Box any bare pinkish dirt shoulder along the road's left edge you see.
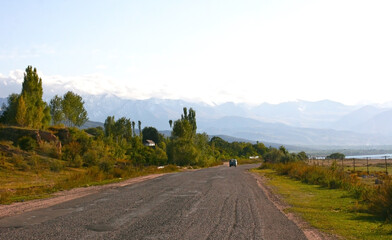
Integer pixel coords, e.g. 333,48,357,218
0,173,164,218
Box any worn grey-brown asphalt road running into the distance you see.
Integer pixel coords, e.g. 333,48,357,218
0,165,306,240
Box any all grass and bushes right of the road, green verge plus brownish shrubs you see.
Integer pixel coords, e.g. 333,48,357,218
255,146,392,239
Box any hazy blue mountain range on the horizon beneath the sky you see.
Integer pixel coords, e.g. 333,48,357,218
0,94,392,146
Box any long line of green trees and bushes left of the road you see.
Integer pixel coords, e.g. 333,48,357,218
0,66,306,173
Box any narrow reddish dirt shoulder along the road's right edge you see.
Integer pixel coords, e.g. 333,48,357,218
251,173,339,240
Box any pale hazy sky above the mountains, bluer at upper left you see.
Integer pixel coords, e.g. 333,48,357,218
0,0,392,104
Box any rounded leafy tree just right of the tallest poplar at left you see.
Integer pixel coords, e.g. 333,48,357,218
62,91,88,127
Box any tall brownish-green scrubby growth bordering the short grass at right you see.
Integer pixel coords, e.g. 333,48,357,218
260,162,392,220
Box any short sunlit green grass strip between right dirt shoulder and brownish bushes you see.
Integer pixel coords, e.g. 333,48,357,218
253,169,392,239
